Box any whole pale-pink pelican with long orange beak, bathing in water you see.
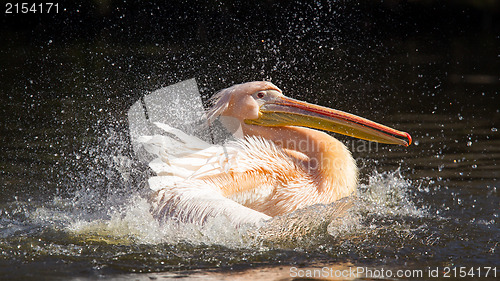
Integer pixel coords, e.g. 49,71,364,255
139,81,411,226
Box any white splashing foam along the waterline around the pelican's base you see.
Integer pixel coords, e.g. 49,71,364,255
27,166,424,248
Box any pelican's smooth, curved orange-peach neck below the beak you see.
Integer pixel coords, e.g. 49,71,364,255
242,124,357,200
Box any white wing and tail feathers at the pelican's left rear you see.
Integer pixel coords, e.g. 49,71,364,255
138,123,271,226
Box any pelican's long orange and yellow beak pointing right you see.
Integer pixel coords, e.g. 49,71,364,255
245,95,411,146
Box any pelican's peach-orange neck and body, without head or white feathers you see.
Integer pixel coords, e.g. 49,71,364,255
213,125,357,217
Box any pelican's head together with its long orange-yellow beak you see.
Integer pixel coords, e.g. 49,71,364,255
208,81,411,146
